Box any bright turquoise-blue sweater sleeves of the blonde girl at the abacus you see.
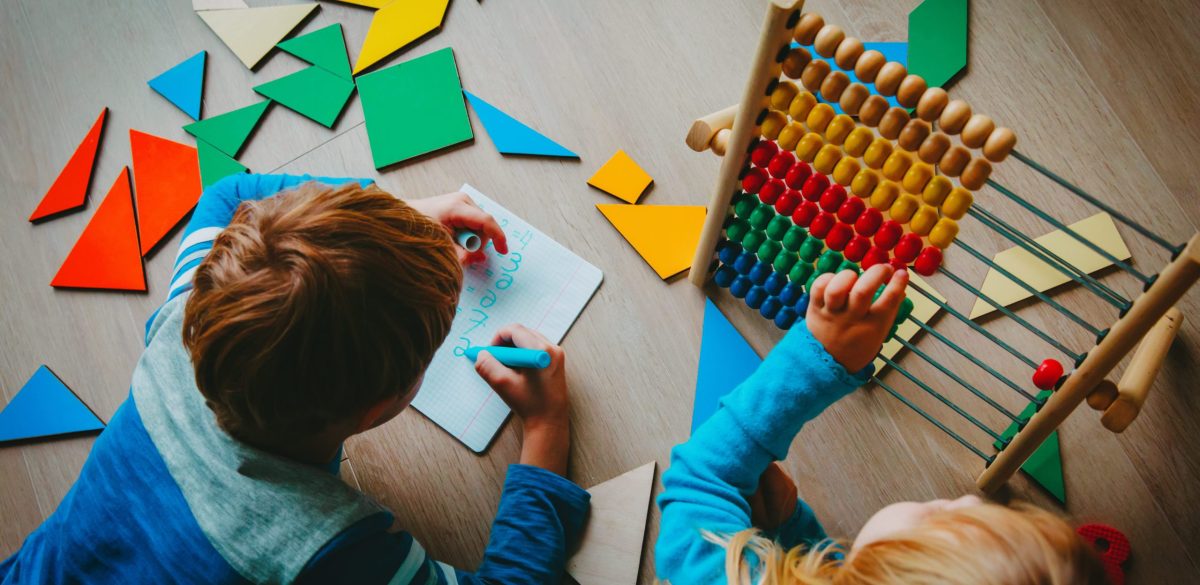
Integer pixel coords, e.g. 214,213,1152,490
654,321,874,585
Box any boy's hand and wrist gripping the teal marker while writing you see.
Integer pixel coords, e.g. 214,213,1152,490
475,325,571,475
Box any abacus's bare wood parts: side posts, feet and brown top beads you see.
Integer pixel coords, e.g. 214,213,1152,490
686,0,1200,493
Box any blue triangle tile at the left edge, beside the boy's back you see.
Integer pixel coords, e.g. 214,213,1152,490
0,366,104,442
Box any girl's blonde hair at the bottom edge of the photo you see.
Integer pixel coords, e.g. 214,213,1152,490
722,503,1109,585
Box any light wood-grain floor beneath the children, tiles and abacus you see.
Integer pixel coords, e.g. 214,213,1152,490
0,0,1200,583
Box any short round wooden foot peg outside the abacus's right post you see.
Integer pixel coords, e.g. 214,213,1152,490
1100,307,1183,433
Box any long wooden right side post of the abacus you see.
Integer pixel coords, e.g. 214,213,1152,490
976,234,1200,493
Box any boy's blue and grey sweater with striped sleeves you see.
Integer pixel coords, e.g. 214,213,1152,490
0,175,588,585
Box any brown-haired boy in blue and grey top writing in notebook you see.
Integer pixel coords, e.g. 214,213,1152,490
0,175,588,584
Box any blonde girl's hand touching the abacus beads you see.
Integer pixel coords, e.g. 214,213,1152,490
805,264,908,373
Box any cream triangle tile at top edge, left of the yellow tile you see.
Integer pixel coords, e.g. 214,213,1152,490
197,2,317,68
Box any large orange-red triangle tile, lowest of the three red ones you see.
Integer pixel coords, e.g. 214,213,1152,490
50,167,146,291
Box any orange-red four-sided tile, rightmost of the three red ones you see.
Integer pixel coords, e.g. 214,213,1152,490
130,129,200,255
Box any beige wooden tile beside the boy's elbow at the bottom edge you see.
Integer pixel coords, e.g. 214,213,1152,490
566,462,654,585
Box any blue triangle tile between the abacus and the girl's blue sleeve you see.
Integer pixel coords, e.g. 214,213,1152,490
691,300,762,433
